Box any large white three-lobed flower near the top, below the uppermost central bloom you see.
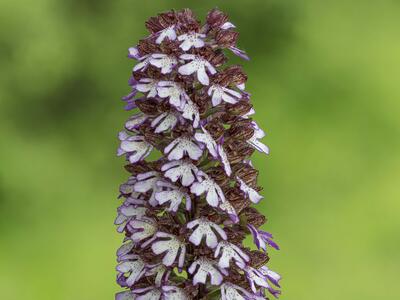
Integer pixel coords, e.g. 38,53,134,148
178,54,217,85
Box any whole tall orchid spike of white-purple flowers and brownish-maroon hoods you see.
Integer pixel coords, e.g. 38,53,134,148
115,9,280,300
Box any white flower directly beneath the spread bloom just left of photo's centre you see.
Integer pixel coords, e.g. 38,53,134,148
161,160,198,186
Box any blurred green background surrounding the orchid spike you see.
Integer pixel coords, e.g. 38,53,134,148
0,0,400,300
